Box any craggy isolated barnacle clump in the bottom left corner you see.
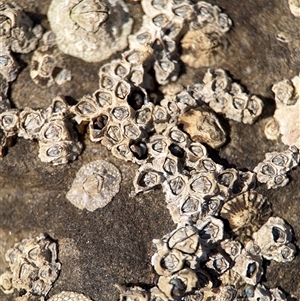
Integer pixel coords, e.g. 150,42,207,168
0,234,61,300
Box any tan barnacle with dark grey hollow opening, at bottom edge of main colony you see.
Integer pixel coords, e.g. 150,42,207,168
157,268,198,300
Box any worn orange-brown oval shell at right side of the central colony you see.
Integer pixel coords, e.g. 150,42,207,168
179,108,226,148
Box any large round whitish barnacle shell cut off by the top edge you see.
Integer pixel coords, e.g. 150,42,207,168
48,0,133,62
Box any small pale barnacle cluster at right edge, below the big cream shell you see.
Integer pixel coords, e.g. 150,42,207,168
254,146,300,189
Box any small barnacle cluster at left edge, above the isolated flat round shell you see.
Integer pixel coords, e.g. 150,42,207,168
0,96,82,165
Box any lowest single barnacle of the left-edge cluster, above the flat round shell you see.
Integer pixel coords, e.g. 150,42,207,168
39,140,82,165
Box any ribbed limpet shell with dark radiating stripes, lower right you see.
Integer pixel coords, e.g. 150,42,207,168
220,190,272,238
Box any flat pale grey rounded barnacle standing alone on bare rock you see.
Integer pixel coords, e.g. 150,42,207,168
66,160,121,211
